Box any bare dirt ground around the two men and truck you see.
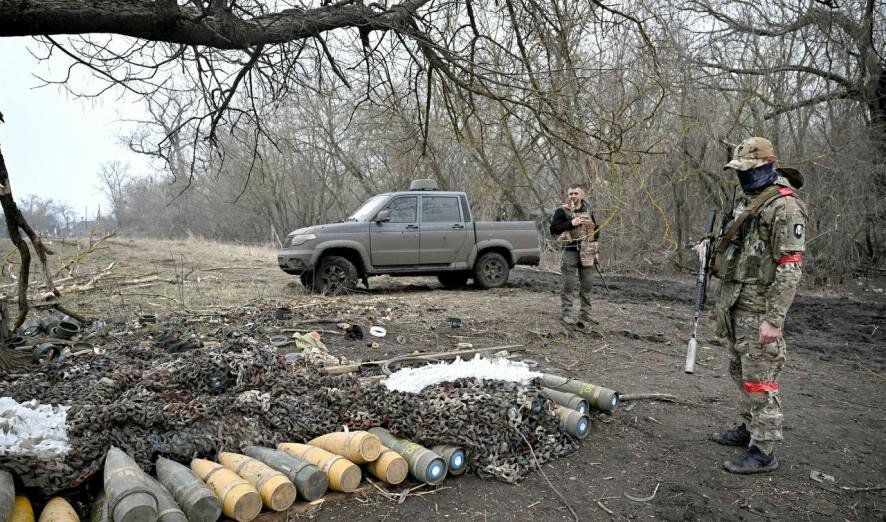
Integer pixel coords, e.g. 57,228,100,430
6,240,886,520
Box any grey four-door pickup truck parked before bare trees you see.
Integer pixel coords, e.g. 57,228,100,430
277,180,540,294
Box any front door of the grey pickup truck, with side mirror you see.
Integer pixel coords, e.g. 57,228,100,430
369,196,419,266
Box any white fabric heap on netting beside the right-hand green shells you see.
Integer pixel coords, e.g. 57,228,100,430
382,354,541,393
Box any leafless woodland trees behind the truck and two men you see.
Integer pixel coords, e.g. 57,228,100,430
6,0,886,277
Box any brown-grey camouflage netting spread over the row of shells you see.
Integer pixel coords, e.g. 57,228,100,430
0,338,578,495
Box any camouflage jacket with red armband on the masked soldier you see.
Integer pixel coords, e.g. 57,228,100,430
717,177,807,336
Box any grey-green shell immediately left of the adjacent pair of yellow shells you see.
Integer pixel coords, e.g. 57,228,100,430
156,457,221,522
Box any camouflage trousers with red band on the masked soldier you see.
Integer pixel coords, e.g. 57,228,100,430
729,310,786,453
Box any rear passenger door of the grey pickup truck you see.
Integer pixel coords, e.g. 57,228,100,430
420,196,468,265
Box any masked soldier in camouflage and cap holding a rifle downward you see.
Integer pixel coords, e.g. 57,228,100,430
712,138,806,474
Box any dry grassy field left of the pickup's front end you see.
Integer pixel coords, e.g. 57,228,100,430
0,238,304,315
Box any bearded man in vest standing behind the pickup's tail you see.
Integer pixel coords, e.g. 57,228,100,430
550,184,600,330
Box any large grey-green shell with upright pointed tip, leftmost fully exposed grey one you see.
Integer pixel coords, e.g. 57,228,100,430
104,447,157,522
